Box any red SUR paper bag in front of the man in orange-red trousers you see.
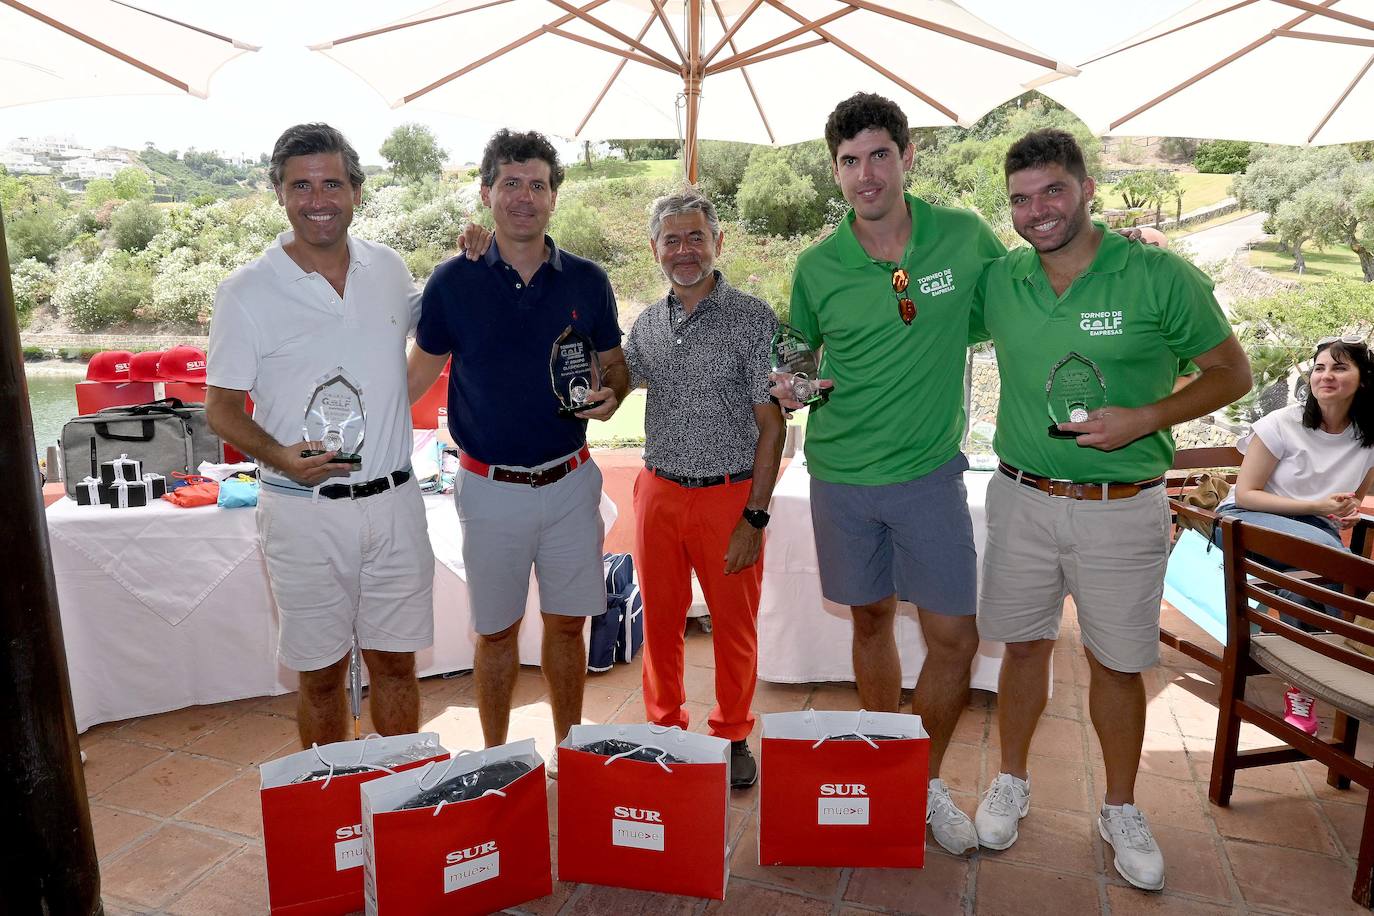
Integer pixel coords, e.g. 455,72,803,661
558,725,730,900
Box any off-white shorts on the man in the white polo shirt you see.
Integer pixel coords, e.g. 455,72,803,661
257,477,434,672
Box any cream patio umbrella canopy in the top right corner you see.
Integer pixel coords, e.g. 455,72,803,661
1043,0,1374,146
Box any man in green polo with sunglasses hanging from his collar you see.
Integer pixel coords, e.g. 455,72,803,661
782,93,1004,854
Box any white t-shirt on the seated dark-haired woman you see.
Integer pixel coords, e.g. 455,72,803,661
1224,404,1374,504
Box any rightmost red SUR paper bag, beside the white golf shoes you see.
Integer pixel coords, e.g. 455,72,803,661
758,710,930,868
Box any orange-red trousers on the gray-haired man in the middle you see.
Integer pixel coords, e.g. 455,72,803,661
635,470,764,742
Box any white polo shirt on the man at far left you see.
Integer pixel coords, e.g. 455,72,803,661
206,232,420,488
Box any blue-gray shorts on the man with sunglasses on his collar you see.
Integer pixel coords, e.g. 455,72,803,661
811,455,978,617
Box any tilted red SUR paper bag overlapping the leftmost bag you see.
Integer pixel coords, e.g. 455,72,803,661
363,740,554,916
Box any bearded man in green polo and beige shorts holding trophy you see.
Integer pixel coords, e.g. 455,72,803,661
970,130,1250,890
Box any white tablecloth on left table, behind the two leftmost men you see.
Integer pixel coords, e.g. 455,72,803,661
48,494,616,732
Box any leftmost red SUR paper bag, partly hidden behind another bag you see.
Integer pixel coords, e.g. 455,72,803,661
260,732,448,916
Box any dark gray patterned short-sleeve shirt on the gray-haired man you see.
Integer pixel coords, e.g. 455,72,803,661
625,271,778,477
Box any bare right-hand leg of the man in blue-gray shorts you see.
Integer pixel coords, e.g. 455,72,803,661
899,610,978,779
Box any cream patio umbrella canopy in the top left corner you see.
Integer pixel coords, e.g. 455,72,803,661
0,0,257,107
